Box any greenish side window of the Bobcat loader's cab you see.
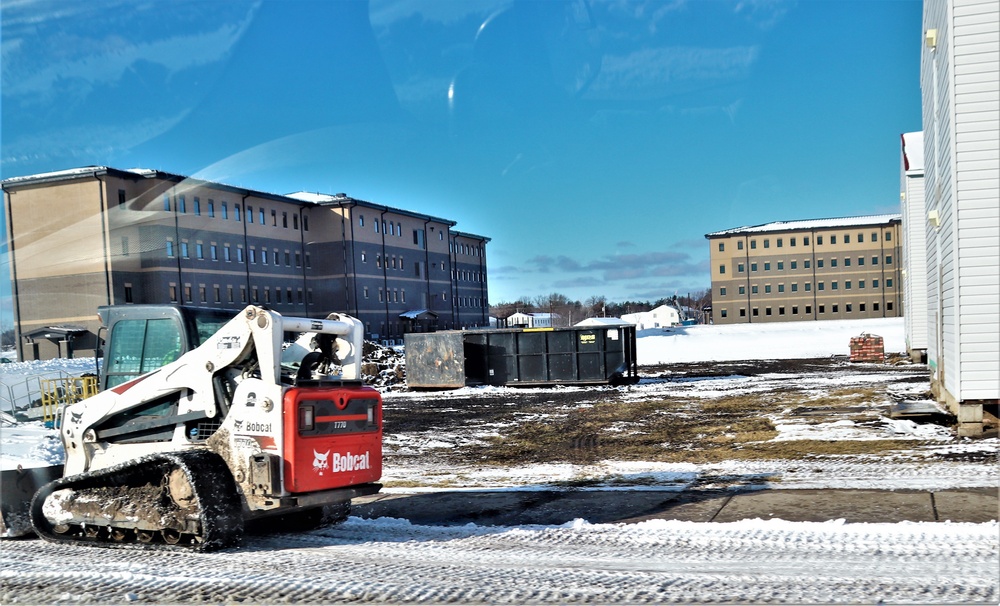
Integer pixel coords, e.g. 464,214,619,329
104,318,183,389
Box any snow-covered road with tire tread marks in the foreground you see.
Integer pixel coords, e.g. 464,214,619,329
0,518,1000,603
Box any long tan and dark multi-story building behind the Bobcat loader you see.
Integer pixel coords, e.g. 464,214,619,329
3,166,489,359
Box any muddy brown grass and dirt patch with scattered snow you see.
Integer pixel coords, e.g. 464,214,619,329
384,358,996,476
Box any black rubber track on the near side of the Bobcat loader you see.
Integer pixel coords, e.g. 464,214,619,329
31,450,243,551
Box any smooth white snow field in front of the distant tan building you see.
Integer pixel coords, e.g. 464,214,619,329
636,318,906,366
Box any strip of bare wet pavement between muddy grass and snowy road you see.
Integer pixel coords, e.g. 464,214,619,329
352,487,1000,526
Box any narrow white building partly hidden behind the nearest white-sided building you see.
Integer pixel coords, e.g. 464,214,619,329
899,132,927,363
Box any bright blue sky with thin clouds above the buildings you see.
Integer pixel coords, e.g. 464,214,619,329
0,0,922,324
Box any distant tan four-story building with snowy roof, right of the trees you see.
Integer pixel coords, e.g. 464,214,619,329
705,215,903,324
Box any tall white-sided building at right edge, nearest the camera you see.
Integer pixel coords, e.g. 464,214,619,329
920,0,1000,436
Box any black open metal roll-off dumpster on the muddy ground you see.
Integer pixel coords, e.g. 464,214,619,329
405,326,639,389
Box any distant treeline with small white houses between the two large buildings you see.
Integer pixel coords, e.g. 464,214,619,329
490,289,712,326
